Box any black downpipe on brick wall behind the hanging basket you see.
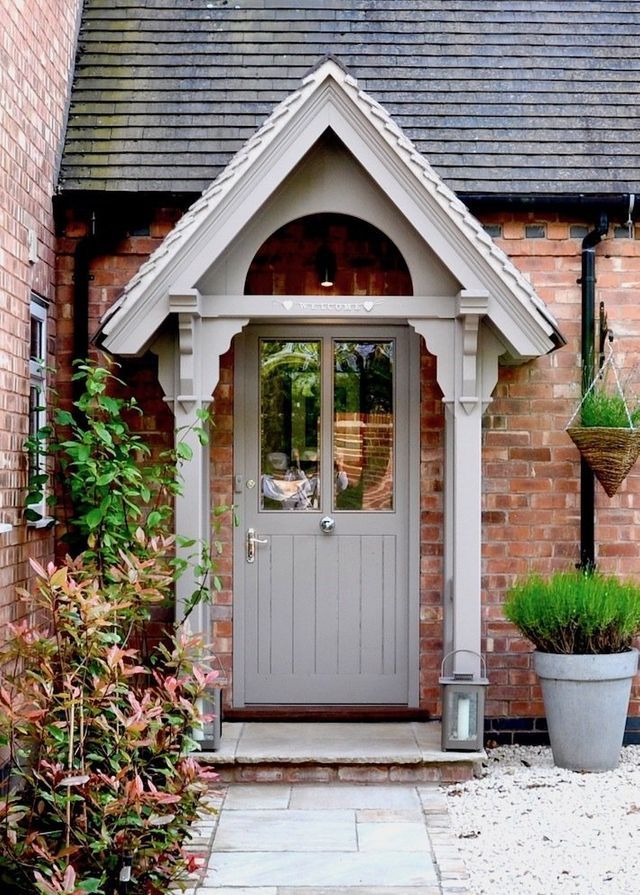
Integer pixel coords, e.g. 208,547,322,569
580,214,609,572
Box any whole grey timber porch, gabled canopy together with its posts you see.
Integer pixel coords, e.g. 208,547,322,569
99,57,563,670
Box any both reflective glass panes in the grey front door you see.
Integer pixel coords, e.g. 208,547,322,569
260,339,395,511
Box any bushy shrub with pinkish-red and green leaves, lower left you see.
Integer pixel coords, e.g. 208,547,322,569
0,532,217,895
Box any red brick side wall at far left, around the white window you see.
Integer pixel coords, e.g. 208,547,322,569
0,0,81,626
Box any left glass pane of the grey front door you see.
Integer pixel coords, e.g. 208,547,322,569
260,339,321,510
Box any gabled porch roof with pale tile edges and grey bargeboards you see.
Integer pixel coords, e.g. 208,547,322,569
100,58,562,361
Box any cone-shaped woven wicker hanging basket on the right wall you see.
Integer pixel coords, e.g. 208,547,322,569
567,426,640,497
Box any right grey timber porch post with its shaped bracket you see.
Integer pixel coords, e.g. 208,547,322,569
409,291,504,674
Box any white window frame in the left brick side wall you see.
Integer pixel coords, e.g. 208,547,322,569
27,293,54,528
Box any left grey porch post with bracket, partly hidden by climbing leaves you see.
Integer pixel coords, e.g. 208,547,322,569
152,290,248,639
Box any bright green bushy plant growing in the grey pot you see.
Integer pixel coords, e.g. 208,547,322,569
504,571,640,654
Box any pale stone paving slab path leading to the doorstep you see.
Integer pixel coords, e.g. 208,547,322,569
182,783,473,895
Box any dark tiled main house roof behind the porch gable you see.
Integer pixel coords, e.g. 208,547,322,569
60,0,640,197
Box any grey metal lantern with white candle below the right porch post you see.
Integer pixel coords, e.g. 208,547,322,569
440,650,489,752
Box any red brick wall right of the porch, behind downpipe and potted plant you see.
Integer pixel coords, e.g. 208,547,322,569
483,214,640,717
